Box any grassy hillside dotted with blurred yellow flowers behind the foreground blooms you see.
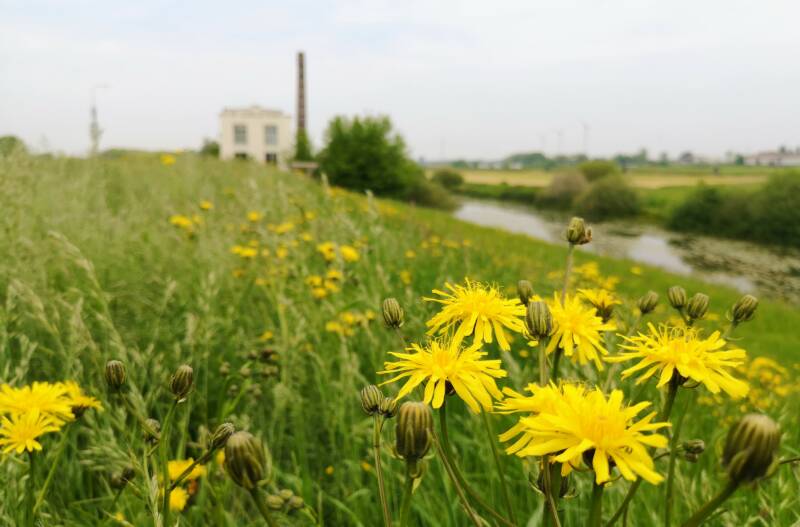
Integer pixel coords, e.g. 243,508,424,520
0,155,800,527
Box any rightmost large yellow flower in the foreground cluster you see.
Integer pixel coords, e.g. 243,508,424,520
606,324,749,399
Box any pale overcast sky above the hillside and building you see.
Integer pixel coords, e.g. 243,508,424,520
0,0,800,160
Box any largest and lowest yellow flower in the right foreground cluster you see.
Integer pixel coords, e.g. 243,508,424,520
506,384,669,484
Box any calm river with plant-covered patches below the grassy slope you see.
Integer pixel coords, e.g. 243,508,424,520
454,199,800,303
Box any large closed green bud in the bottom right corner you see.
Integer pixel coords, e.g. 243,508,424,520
722,414,781,483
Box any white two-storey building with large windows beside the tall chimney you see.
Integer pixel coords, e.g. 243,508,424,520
219,106,294,168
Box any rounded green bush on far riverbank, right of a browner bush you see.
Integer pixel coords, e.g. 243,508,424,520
575,176,641,221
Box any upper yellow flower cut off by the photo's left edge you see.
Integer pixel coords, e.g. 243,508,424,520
0,382,74,425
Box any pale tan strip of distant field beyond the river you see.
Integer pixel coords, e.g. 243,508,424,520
444,167,771,188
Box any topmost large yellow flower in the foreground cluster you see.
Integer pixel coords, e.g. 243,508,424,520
423,279,525,351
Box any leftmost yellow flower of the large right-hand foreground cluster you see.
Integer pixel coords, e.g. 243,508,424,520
378,340,507,413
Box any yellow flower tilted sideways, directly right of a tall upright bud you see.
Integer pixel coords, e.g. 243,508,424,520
545,293,616,370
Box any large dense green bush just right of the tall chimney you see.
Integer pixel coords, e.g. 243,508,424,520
319,116,424,197
